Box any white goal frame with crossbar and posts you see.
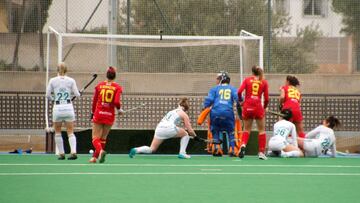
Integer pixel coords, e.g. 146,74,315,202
45,26,263,127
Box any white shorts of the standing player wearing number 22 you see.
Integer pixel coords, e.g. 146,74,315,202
53,104,75,122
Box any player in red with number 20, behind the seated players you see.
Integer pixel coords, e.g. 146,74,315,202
279,75,305,138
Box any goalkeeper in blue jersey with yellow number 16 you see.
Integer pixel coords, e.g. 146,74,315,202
203,71,241,156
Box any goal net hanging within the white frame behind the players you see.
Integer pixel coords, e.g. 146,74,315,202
46,27,263,128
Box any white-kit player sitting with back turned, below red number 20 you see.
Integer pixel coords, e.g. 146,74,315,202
269,109,304,157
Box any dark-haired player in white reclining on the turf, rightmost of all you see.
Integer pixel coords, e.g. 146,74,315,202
298,116,340,157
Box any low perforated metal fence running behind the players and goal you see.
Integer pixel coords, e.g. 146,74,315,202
0,92,360,131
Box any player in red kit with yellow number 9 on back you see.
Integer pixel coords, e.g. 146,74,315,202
238,66,269,160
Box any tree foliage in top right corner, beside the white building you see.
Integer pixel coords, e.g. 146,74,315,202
332,0,360,71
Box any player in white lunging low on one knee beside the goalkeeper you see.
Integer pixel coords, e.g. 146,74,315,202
129,98,196,159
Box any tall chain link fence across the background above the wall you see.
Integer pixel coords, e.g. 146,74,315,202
0,0,360,74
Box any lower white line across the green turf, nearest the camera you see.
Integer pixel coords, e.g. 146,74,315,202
0,172,360,176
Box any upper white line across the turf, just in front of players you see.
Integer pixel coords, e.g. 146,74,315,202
0,163,360,168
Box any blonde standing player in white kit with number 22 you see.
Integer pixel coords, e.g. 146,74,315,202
46,63,80,160
